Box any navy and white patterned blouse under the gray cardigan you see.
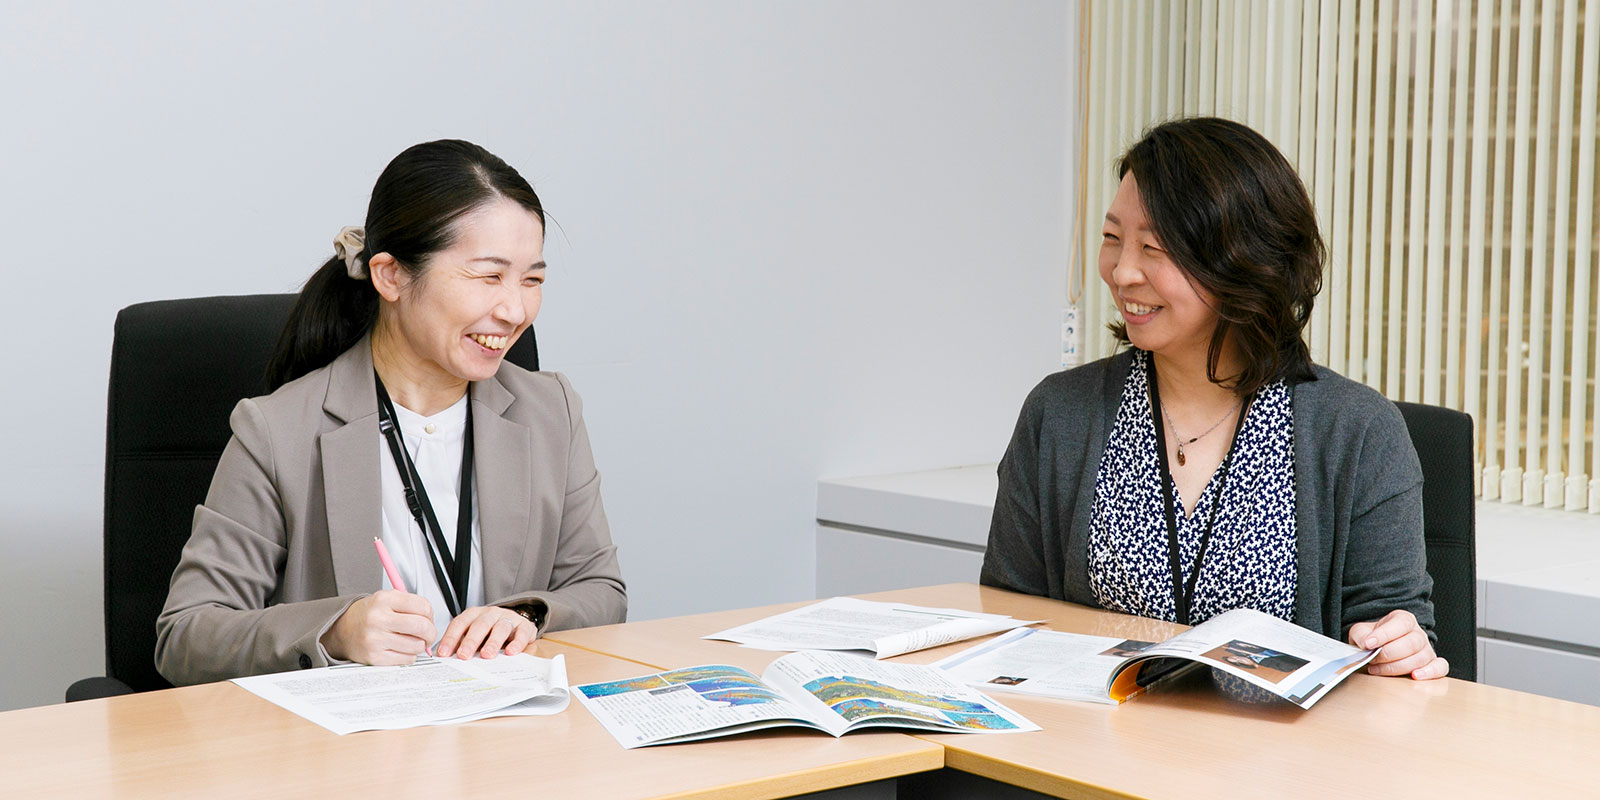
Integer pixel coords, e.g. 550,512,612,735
1090,352,1296,624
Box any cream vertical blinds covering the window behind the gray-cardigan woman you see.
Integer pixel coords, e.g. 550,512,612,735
1067,0,1600,514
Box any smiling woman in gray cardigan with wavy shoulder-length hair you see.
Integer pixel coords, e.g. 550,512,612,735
982,118,1448,678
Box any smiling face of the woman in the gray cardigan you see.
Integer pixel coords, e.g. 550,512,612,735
1099,171,1218,365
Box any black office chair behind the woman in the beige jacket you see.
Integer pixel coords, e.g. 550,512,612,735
67,294,539,702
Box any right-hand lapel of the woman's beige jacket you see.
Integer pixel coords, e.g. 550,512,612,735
472,371,533,603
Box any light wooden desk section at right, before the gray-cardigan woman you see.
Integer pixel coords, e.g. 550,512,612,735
552,584,1600,798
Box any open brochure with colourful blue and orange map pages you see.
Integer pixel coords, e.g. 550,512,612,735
576,651,1038,747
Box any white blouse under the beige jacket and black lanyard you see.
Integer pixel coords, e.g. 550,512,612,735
376,392,483,643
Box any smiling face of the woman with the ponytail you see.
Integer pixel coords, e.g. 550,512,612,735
371,198,544,390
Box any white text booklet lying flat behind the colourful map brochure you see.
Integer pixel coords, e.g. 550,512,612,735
701,597,1040,658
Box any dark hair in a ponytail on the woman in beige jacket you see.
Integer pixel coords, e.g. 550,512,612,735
267,139,544,392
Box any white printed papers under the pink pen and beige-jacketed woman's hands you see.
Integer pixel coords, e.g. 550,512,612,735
234,653,571,736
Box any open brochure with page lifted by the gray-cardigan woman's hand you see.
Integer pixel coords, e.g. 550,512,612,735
933,608,1378,709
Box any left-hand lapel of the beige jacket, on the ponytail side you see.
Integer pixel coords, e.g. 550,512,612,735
317,338,382,595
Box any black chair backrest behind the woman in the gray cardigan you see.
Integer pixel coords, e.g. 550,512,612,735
1395,403,1478,680
